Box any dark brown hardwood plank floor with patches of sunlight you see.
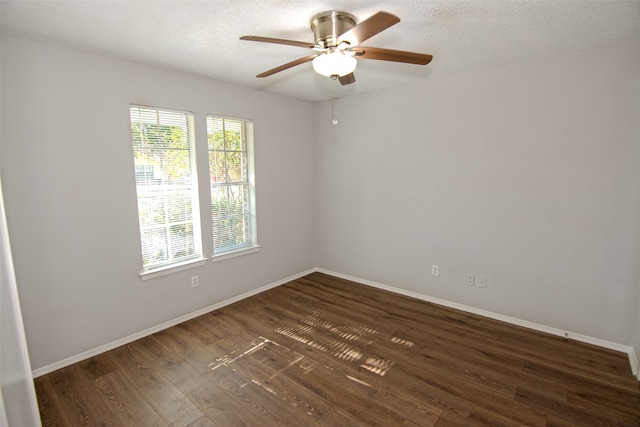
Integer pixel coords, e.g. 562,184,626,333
36,273,640,427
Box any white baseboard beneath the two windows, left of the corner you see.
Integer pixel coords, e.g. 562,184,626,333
32,268,317,378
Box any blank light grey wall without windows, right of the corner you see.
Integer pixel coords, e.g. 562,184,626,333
315,43,640,345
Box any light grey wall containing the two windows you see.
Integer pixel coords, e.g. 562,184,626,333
1,36,315,369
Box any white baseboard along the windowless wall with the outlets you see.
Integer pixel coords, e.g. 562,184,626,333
316,268,640,379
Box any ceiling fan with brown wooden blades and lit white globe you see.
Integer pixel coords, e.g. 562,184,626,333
240,10,433,85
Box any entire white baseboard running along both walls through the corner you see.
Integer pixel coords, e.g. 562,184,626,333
32,268,640,380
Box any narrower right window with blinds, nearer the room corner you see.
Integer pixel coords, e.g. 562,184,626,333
207,116,257,257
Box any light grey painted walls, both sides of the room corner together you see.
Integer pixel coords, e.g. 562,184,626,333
1,36,640,369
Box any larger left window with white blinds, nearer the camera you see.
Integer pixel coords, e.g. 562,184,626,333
130,105,202,272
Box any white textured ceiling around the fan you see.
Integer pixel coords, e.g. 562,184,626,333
1,0,640,101
